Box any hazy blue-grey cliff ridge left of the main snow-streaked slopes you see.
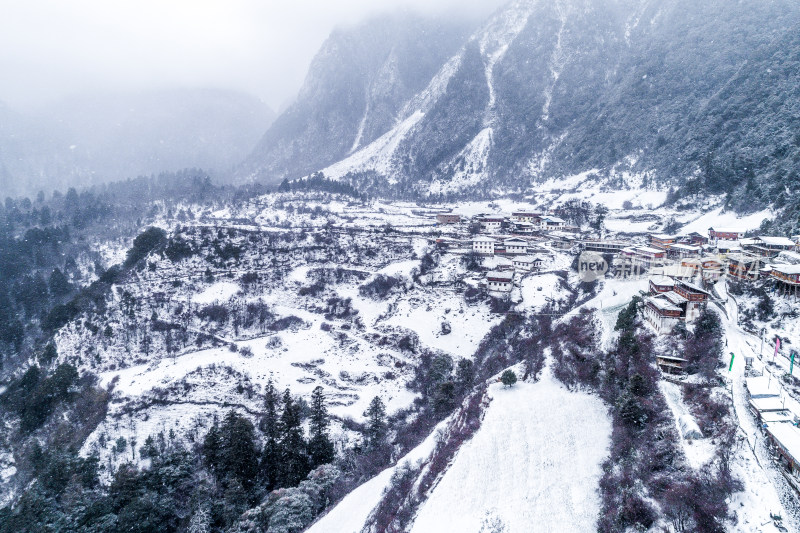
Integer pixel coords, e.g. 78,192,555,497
240,14,476,182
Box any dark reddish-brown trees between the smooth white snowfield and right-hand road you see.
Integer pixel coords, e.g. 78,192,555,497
552,297,740,532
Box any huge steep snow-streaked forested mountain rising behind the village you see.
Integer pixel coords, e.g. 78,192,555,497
245,0,800,207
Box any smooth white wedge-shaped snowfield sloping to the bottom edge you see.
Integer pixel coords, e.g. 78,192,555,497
411,369,611,533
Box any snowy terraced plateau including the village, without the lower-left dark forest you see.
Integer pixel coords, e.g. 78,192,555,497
0,174,800,532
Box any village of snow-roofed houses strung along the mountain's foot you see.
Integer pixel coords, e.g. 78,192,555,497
436,211,800,302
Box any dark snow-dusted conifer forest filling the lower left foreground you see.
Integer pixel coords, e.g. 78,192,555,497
0,378,389,533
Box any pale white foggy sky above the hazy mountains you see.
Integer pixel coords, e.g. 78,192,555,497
0,0,504,110
